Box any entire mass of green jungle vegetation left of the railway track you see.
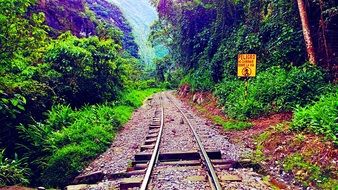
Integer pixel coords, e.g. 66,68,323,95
0,0,158,187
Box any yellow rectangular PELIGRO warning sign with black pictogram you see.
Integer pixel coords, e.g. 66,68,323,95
237,54,257,77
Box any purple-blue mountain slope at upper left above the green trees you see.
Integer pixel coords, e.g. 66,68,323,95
34,0,139,57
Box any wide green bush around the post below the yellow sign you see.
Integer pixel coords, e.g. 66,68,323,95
215,64,330,120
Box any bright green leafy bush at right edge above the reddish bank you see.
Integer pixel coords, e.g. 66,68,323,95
291,91,338,144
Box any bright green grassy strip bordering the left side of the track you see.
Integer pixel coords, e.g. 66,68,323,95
19,89,160,187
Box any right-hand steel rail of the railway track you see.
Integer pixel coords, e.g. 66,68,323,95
167,92,222,190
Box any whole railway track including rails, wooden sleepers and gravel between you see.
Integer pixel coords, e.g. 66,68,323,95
73,93,251,190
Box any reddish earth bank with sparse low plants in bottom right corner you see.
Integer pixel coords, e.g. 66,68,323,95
250,122,338,189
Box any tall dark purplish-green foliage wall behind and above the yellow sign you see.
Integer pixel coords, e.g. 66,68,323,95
151,0,305,83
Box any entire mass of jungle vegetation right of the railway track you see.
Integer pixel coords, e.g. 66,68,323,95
150,0,338,189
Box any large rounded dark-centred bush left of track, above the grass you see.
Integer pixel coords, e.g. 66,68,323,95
45,34,132,106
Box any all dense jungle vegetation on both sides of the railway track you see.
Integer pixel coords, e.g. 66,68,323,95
0,0,338,189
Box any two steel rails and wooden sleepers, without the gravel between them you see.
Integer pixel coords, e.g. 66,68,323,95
120,93,235,190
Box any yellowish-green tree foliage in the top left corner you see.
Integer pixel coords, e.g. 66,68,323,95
0,0,49,72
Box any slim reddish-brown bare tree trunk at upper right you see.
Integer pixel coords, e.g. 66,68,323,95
297,0,317,65
